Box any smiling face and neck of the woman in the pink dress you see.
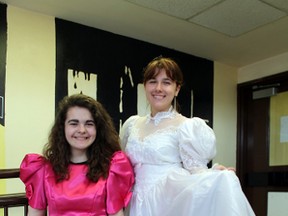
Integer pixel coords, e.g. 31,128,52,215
65,106,96,161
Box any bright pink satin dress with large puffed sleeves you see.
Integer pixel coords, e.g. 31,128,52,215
20,151,134,216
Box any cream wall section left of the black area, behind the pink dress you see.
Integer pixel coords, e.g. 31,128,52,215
5,6,56,191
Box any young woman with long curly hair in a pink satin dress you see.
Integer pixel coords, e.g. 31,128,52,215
20,94,134,216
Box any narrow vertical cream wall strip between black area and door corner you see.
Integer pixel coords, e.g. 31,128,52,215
213,62,237,167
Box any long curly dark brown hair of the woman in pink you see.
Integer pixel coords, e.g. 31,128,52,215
43,94,121,182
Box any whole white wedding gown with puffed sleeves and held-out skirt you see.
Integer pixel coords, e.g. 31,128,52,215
120,110,255,216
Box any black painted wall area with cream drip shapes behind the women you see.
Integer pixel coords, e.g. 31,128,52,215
55,18,213,128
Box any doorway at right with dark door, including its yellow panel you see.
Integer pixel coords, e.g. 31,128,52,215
237,72,288,216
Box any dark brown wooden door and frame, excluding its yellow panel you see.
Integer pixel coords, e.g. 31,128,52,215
236,72,288,216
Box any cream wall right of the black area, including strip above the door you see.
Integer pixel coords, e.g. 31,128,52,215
213,53,288,167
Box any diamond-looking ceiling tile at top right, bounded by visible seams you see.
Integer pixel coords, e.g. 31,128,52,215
189,0,287,37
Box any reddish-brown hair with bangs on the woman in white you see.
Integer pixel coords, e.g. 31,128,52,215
143,56,183,111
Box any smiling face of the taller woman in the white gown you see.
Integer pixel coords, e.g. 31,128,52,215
144,69,180,116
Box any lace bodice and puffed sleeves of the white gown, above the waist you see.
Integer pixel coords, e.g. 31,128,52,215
121,111,216,172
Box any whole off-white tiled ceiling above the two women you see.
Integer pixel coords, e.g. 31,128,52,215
0,0,288,67
